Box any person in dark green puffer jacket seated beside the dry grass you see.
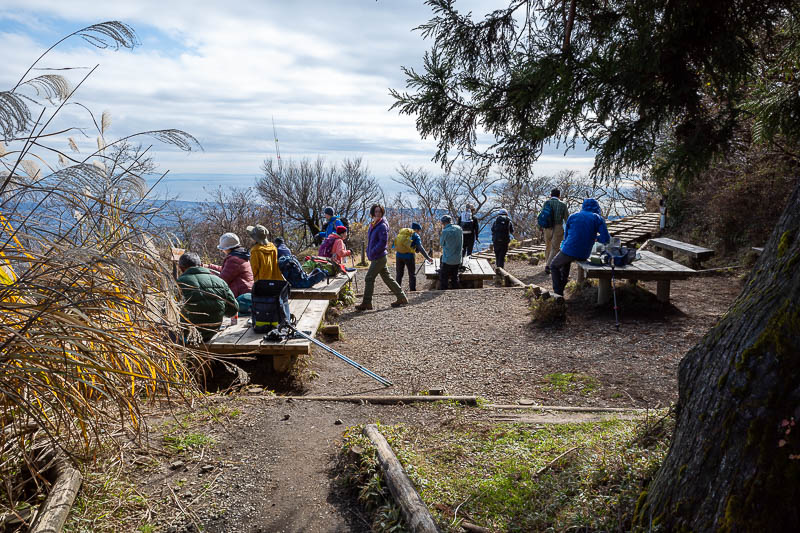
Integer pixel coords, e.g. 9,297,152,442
178,252,239,342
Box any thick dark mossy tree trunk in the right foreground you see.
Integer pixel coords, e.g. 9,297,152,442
634,181,800,531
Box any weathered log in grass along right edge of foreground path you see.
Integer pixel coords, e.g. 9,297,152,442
364,424,439,533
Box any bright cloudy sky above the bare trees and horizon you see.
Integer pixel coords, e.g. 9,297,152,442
0,0,592,199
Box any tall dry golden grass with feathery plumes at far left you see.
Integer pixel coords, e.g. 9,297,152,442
0,22,198,529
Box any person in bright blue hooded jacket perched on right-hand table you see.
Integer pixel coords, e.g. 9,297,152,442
550,198,611,296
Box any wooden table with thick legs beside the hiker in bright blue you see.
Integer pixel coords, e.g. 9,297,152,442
578,251,696,304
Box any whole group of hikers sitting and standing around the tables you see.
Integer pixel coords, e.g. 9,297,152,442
178,194,610,342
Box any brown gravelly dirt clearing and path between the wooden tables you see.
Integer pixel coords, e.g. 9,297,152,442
134,261,740,532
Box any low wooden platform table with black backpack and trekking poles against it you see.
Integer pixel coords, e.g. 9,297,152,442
206,300,329,372
